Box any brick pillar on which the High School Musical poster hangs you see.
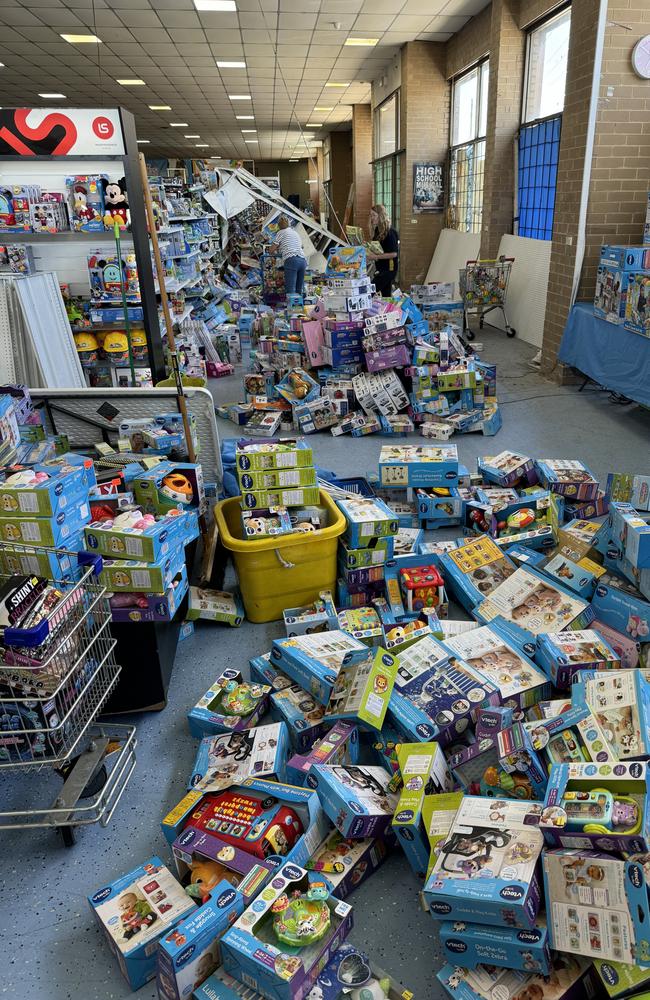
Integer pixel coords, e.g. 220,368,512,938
400,42,449,287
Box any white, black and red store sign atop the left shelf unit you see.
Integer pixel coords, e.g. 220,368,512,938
0,108,125,159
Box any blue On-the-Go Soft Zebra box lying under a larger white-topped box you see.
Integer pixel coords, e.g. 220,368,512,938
438,920,551,976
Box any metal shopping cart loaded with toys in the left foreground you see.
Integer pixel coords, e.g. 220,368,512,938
0,542,136,846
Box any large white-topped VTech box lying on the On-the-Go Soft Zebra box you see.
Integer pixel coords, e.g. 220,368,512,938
424,796,544,928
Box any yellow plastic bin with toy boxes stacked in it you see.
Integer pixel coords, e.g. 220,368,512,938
214,490,346,622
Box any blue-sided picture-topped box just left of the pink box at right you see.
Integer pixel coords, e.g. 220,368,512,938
535,629,621,688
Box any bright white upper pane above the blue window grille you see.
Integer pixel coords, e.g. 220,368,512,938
522,8,571,124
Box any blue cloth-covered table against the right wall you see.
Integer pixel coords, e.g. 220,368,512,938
558,302,650,406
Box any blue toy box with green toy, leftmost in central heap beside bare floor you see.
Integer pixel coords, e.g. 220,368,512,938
187,668,271,737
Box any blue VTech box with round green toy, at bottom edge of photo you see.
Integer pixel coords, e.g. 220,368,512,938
221,864,352,1000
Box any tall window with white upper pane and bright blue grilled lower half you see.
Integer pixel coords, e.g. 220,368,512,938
515,7,571,240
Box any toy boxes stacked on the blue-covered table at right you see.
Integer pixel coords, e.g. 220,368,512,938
594,244,650,337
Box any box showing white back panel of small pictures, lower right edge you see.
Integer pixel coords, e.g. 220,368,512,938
543,849,650,965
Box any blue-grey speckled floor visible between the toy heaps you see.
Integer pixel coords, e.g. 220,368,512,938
0,330,650,1000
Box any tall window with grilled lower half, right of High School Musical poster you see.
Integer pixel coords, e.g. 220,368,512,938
449,59,490,233
